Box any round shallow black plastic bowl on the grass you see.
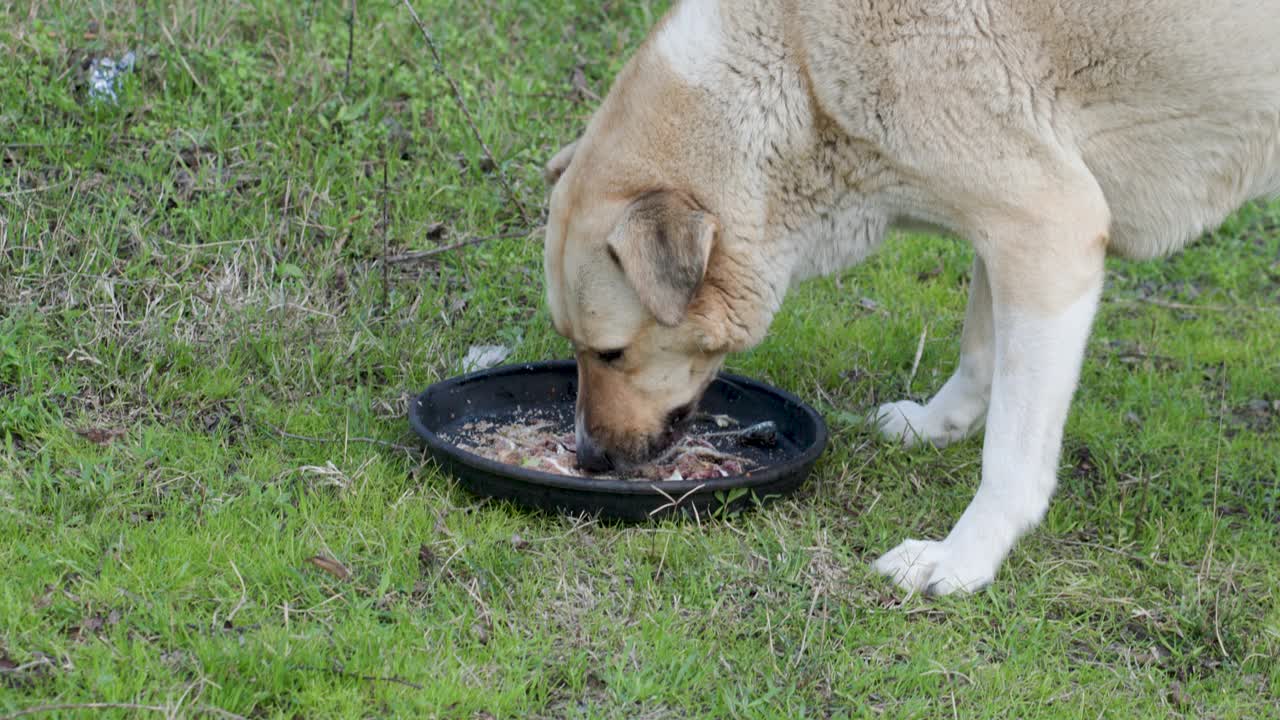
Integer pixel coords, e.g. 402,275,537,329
410,360,827,521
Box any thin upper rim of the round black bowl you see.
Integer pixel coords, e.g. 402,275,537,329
410,360,829,491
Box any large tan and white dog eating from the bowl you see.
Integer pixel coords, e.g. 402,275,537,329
544,0,1280,594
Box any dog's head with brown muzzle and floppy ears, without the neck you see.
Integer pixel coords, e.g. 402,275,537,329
545,158,728,471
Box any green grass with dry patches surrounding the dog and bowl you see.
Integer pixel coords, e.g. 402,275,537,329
0,0,1280,717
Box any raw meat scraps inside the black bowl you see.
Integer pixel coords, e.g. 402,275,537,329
452,415,777,480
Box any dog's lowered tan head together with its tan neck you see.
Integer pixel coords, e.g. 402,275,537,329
544,3,808,470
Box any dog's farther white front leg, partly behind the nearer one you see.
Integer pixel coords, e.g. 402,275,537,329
876,252,995,447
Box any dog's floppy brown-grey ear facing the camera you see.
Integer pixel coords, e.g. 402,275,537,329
608,191,719,327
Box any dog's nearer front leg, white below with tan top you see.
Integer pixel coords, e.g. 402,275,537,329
874,214,1106,594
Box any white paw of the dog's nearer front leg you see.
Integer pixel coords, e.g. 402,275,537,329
872,539,998,596
